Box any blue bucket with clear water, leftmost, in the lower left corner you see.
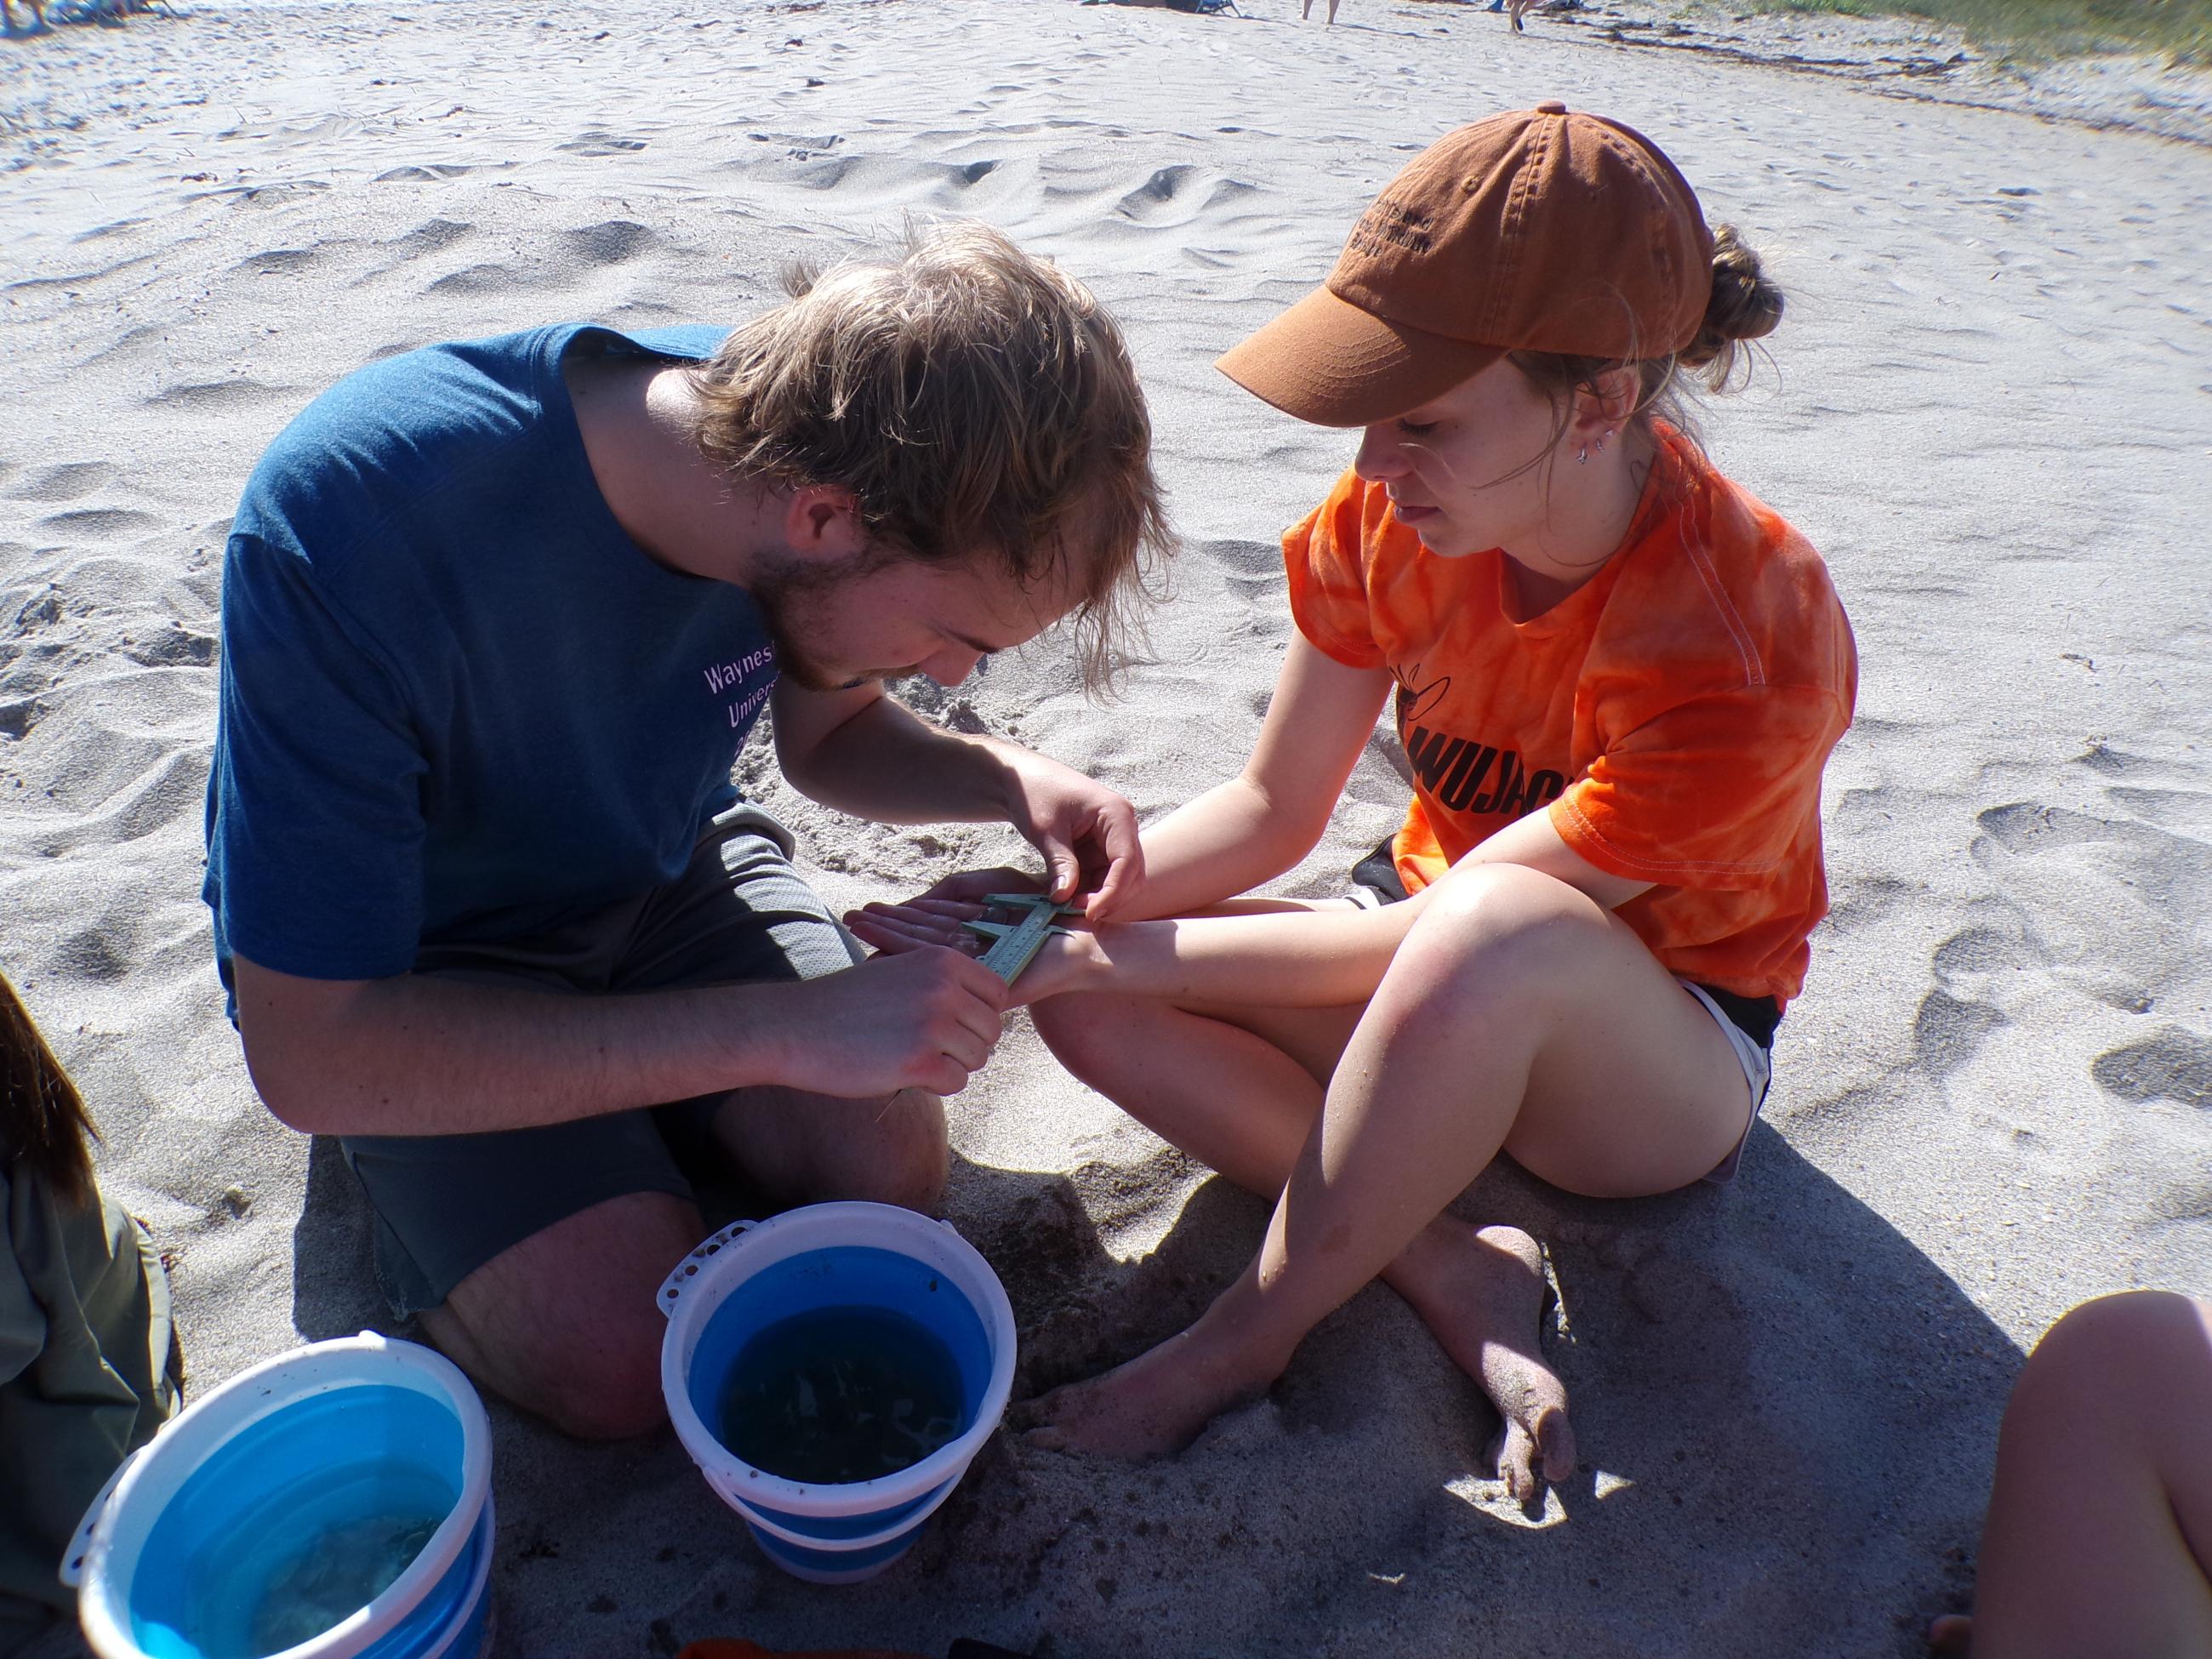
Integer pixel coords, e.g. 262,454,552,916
62,1331,493,1659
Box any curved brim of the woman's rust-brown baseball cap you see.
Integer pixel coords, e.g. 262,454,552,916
1214,288,1504,427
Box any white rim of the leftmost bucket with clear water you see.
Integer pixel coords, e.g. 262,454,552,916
71,1331,491,1659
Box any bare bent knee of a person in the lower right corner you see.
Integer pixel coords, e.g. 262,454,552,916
1929,1290,2212,1659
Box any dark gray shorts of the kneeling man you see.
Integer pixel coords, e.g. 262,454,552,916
340,805,860,1319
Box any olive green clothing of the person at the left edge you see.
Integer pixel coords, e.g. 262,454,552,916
0,1148,177,1655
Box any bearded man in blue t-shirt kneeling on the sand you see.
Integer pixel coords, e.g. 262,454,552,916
206,225,1168,1435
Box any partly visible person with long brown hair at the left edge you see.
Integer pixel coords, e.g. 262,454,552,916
0,976,180,1655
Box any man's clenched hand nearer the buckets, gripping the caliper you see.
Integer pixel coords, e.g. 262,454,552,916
752,944,1011,1099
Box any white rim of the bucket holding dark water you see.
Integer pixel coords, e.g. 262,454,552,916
654,1199,1013,1531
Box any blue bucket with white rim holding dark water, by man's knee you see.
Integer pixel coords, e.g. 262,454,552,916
659,1203,1013,1584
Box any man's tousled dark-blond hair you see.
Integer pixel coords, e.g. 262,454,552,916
690,221,1175,693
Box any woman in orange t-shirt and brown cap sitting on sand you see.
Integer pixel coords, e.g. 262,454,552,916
856,104,1856,1497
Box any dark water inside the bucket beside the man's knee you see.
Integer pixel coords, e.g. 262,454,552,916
719,1308,962,1486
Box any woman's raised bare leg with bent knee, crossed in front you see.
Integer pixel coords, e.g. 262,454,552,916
1026,865,1750,1456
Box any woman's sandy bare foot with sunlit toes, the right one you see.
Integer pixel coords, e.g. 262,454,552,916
1385,1217,1575,1504
